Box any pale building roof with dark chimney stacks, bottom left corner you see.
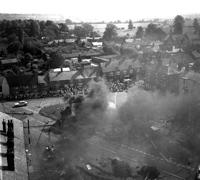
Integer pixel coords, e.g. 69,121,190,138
0,112,28,180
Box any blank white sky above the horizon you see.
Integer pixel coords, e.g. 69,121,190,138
0,0,200,21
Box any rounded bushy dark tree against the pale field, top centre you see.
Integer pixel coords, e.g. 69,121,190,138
103,23,117,41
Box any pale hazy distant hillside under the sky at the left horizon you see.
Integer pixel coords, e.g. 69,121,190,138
0,13,65,21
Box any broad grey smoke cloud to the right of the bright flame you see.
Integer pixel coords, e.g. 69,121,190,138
115,87,200,164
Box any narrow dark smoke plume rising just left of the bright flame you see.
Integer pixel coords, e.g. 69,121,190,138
33,81,108,180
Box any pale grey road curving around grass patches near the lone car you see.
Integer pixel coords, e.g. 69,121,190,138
0,98,63,173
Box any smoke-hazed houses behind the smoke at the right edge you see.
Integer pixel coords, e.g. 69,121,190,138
144,60,200,94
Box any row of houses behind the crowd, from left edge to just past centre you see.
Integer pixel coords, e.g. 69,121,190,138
0,57,141,97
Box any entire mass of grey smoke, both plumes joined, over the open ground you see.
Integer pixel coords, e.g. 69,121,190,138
34,80,200,180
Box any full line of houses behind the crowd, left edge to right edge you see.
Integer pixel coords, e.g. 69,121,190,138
0,53,198,97
